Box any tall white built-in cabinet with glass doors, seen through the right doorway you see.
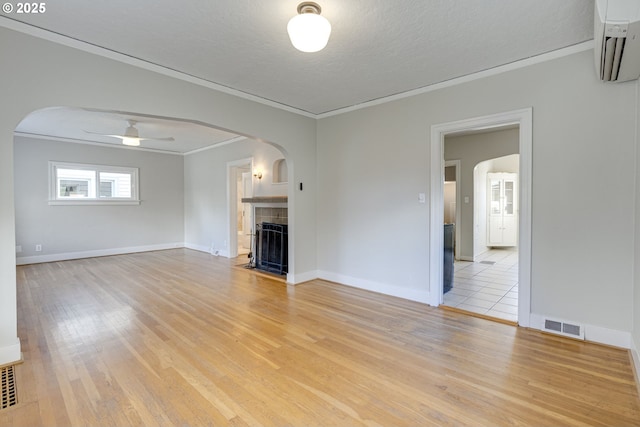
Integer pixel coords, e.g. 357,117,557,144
487,172,518,246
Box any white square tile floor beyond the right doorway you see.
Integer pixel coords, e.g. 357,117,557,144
444,248,518,322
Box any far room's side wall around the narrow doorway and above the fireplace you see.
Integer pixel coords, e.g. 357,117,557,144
184,139,288,254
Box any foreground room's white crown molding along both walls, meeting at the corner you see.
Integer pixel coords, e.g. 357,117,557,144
0,16,594,119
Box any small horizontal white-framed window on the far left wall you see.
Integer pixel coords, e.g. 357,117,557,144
49,162,140,205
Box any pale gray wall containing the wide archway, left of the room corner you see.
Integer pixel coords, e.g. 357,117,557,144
0,25,316,364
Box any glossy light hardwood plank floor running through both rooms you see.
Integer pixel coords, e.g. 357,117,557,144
0,249,640,426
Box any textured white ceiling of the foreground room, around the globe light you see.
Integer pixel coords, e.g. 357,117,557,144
0,0,594,152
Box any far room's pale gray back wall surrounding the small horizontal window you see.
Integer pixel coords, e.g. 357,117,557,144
14,136,184,263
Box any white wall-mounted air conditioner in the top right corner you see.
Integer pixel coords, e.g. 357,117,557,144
593,0,640,82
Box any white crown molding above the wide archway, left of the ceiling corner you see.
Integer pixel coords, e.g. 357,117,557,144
0,16,315,118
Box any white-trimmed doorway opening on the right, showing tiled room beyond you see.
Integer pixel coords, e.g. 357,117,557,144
443,150,519,322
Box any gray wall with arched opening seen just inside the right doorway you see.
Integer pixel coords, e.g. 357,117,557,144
444,129,519,260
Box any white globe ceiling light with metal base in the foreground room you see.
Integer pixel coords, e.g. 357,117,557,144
287,1,331,52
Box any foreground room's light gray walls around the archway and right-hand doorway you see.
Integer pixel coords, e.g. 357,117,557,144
0,23,640,374
